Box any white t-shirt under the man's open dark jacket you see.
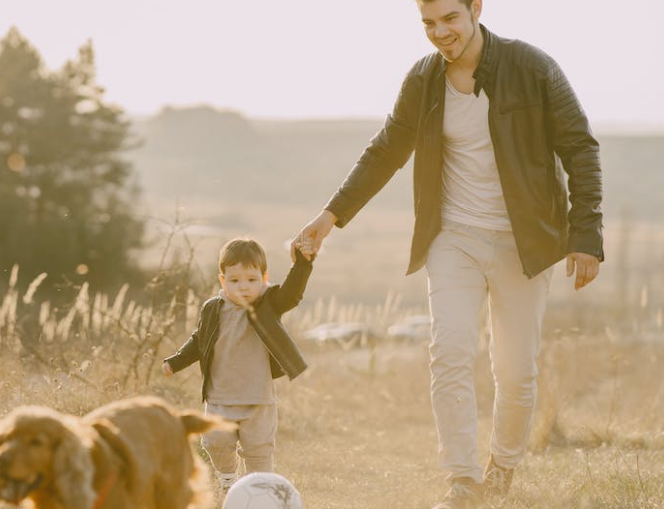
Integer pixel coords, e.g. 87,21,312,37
442,75,512,231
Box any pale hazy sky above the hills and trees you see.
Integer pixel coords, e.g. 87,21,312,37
0,0,664,129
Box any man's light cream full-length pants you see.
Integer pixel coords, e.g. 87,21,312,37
427,222,553,482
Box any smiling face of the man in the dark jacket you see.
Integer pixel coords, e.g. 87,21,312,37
419,0,482,62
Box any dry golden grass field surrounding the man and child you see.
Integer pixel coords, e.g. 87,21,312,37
0,199,664,509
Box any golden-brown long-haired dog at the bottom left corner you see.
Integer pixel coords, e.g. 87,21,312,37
0,397,228,509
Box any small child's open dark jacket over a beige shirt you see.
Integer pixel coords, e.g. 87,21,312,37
164,251,312,401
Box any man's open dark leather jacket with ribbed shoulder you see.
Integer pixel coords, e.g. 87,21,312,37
325,26,604,277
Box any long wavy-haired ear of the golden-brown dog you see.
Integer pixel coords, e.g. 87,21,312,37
52,418,96,509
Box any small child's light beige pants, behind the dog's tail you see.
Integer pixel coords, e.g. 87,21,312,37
201,403,277,474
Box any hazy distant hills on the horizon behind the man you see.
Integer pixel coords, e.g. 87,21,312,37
128,106,664,220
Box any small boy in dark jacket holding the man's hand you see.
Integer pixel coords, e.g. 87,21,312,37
162,238,312,493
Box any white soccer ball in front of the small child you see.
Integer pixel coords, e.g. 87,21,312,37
223,472,304,509
